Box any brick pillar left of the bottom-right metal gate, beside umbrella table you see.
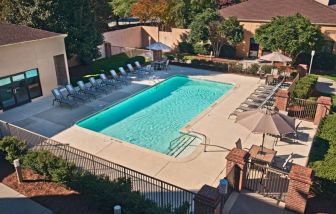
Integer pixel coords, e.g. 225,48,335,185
226,148,250,191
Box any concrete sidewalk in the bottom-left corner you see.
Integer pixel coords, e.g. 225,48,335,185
0,183,52,214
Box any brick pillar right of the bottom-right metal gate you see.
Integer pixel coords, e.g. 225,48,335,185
286,165,313,213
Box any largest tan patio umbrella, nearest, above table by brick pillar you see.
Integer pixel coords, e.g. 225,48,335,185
236,109,295,152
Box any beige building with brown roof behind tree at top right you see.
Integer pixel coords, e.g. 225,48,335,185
220,0,336,58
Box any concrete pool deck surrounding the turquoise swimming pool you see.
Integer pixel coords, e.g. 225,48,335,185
0,66,316,191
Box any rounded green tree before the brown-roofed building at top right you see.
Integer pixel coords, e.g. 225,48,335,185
255,14,323,62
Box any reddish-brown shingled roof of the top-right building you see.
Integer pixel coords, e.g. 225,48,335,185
220,0,336,25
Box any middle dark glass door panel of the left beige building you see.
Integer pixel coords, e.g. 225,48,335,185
12,74,30,105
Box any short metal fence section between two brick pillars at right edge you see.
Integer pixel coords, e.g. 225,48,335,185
287,97,317,121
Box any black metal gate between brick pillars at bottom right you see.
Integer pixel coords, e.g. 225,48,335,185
244,161,289,201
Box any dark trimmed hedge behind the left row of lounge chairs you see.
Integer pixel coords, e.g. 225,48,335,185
69,53,145,85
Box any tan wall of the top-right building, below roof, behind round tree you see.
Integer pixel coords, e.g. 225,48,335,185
236,22,336,58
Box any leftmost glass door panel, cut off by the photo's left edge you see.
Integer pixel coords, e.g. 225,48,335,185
0,77,16,110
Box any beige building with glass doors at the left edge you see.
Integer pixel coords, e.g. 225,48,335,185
0,23,69,110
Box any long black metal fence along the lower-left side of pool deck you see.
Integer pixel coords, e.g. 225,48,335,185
0,121,196,213
